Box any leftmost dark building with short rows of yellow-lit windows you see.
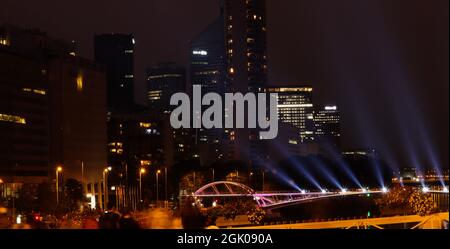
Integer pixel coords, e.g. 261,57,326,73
0,41,50,184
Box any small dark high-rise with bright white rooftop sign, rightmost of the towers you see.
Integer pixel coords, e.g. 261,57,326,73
314,106,341,148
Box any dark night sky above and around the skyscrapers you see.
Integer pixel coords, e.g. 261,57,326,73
0,0,449,168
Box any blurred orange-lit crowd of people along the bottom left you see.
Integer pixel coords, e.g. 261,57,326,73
0,198,217,229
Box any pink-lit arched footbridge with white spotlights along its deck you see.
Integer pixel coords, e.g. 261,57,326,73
193,181,387,208
